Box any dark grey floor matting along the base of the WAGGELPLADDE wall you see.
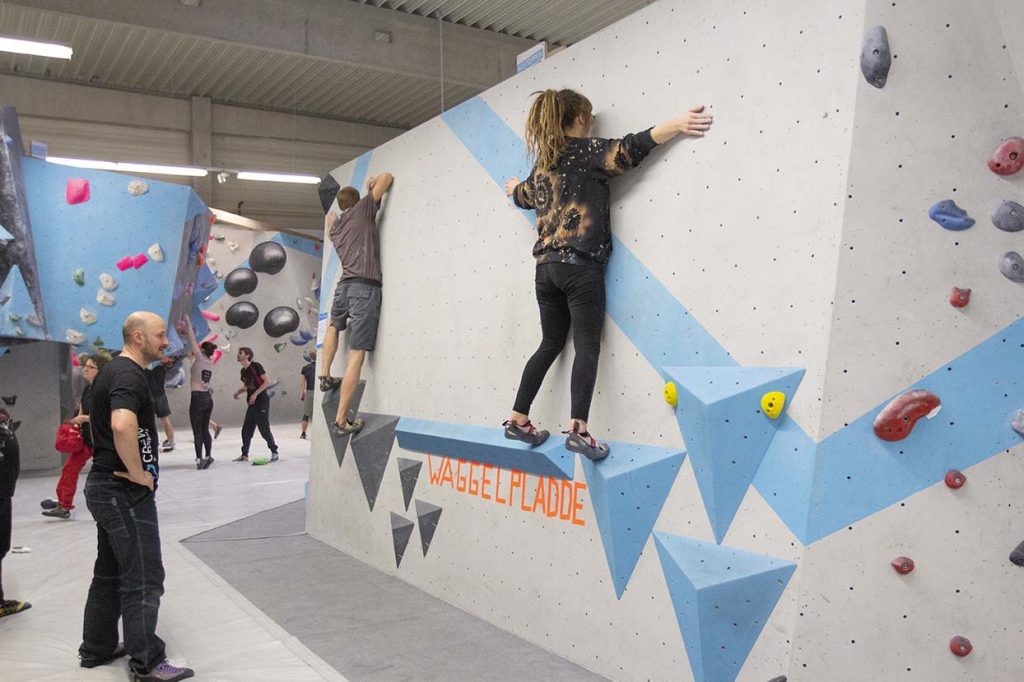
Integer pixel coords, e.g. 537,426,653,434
182,500,604,681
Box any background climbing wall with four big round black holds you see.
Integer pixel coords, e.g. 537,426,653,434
167,224,323,429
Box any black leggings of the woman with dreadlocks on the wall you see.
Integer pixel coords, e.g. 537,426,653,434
513,263,604,422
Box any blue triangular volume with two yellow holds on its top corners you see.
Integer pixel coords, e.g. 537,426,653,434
663,367,804,543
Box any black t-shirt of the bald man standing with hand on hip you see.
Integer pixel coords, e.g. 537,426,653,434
89,356,160,481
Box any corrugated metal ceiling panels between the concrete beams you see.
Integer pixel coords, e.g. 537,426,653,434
0,0,650,128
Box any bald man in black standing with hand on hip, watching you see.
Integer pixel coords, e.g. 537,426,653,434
79,312,195,681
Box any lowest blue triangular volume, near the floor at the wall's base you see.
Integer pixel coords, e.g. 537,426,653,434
654,531,797,682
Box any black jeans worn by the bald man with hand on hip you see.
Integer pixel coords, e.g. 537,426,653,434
79,471,166,673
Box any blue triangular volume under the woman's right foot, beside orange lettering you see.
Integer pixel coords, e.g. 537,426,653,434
581,443,686,599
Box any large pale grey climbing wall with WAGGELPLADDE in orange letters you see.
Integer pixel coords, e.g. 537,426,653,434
307,0,1024,681
